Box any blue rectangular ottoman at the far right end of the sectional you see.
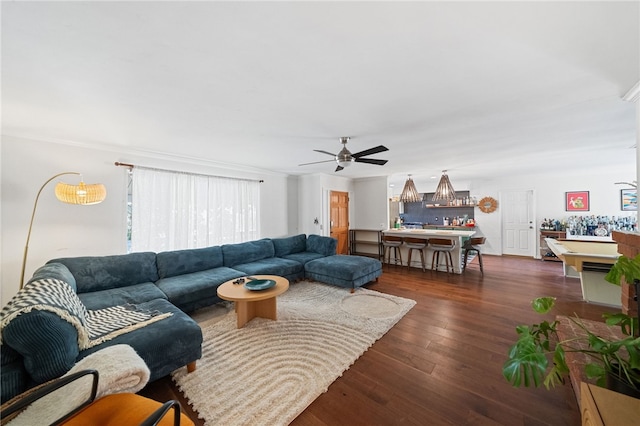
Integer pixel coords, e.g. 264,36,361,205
304,254,382,292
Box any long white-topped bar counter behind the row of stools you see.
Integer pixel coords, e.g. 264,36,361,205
382,229,476,274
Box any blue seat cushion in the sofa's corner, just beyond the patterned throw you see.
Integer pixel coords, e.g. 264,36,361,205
78,283,167,310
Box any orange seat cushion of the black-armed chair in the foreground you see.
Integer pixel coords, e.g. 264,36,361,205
63,393,194,426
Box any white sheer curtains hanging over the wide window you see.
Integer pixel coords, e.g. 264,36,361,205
131,166,260,252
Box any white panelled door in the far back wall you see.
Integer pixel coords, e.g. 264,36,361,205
500,190,536,257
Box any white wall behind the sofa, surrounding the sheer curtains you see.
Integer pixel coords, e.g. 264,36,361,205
0,136,290,306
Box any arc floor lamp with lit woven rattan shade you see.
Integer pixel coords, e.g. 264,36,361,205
20,172,107,288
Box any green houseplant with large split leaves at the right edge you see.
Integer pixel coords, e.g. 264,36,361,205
502,255,640,397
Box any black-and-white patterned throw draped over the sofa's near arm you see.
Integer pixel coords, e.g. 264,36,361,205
0,279,172,350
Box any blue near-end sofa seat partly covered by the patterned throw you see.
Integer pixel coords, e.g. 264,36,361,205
77,299,202,381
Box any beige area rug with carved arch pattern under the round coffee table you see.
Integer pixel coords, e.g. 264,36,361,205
173,281,416,426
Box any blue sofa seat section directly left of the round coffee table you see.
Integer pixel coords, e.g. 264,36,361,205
156,266,246,312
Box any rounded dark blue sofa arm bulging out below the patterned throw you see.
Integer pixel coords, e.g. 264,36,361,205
2,310,79,384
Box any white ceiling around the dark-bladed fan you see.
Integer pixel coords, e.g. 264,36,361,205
2,1,640,186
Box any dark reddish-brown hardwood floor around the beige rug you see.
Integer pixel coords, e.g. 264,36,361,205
141,256,611,426
